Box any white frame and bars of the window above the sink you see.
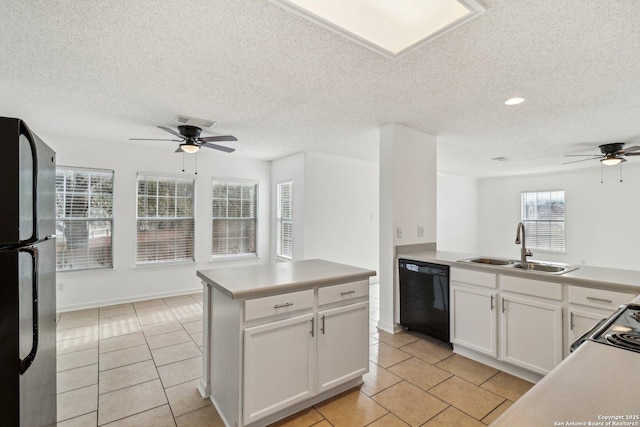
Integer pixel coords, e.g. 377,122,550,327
520,190,567,253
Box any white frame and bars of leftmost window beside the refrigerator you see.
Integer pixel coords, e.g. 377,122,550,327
55,165,115,273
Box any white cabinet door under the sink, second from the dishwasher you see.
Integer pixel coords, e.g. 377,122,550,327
500,295,562,374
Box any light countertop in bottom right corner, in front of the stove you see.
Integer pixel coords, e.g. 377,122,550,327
491,341,640,427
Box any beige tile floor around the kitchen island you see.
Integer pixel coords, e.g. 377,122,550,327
58,285,532,427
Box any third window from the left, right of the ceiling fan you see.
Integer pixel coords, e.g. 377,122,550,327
212,178,258,257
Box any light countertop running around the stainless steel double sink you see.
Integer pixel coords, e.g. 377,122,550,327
399,251,640,294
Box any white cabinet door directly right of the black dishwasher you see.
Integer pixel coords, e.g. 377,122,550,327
451,285,498,357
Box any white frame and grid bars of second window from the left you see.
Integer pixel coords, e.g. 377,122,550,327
134,172,196,268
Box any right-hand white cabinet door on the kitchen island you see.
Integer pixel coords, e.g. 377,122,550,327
318,301,369,393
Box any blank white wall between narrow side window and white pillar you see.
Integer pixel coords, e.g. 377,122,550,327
304,153,379,270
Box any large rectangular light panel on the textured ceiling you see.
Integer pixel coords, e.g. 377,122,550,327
271,0,485,58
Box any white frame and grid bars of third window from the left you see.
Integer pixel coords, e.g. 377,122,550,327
211,177,260,261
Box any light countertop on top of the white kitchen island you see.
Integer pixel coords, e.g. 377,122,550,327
198,259,376,299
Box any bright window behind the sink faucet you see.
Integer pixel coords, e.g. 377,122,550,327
521,191,565,252
